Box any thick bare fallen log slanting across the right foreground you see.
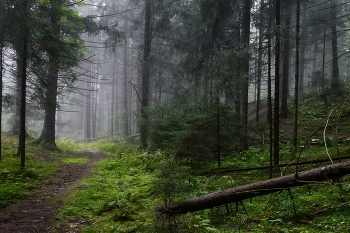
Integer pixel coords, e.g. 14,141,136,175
155,161,350,215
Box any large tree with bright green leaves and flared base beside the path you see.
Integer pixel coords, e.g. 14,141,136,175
36,0,91,148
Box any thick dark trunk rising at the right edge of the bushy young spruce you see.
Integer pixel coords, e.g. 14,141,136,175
241,0,252,150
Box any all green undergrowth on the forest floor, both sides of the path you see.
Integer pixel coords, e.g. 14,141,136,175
0,94,350,233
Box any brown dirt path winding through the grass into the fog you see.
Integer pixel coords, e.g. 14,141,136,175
0,152,106,233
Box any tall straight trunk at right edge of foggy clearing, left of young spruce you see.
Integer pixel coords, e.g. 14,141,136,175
140,0,152,148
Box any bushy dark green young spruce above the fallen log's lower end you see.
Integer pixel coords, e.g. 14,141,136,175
150,99,242,165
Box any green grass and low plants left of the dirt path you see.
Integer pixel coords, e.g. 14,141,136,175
0,136,87,209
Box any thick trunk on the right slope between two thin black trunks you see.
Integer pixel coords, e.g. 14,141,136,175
281,9,291,118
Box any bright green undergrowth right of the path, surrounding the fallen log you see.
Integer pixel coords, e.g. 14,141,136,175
52,141,350,233
